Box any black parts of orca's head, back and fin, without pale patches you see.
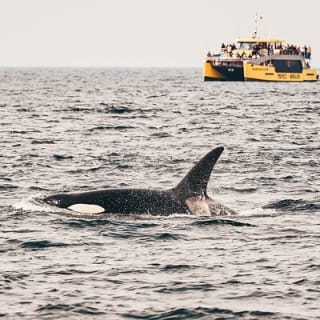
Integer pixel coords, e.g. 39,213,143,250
44,147,223,215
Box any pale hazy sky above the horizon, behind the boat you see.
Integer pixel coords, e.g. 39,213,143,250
0,0,320,68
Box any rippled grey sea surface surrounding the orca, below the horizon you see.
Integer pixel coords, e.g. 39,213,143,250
0,68,320,320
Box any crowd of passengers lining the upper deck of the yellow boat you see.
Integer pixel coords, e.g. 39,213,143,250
207,42,311,60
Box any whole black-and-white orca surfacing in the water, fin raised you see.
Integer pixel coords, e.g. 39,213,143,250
43,147,236,215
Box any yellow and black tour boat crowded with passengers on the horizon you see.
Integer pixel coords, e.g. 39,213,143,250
203,36,319,82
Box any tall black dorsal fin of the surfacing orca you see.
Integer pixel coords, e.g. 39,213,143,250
173,147,224,199
